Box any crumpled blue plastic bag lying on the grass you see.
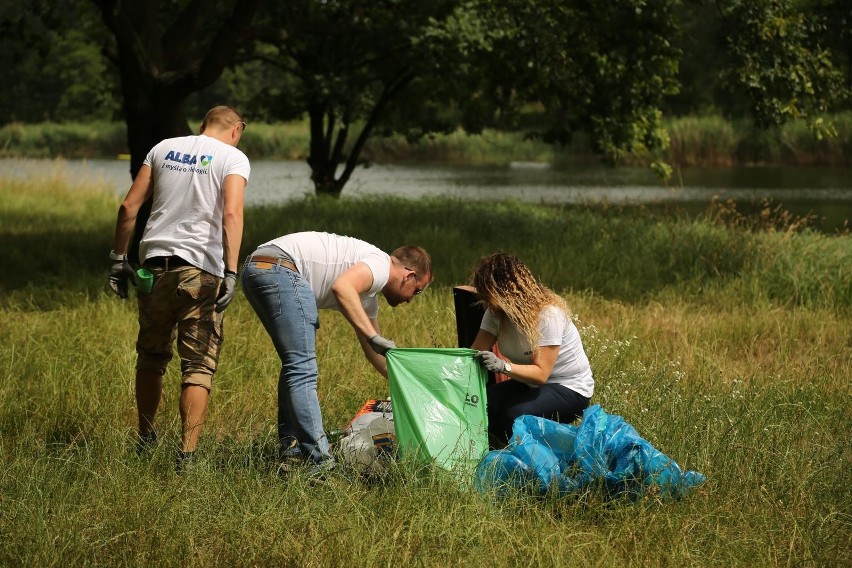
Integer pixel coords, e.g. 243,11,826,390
475,405,706,497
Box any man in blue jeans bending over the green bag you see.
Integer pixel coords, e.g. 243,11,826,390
242,232,432,468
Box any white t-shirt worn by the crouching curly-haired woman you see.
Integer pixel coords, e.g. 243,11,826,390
479,306,595,398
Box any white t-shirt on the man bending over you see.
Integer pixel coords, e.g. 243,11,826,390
258,231,391,319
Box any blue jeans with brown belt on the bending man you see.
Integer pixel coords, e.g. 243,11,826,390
242,257,332,463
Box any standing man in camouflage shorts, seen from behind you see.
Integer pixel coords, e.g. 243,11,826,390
109,106,251,466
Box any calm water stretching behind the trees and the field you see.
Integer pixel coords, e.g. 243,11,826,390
0,159,852,233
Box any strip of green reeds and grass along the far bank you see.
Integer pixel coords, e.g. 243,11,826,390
0,112,852,166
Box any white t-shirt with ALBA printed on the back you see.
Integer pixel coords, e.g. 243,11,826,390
139,134,251,277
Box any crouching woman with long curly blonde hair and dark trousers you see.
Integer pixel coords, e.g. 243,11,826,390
471,252,595,447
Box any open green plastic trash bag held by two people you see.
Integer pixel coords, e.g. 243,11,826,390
387,349,488,469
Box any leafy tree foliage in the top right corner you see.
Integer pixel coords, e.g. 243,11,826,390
665,0,852,123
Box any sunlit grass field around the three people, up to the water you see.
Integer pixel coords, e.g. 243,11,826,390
0,177,852,567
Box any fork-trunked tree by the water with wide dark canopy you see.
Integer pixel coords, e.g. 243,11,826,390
248,0,677,195
